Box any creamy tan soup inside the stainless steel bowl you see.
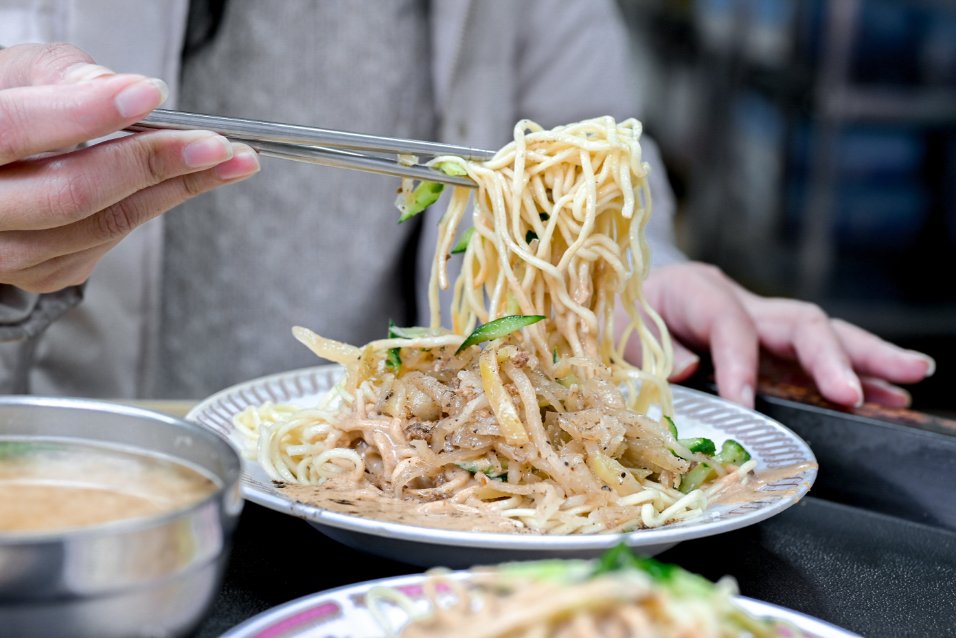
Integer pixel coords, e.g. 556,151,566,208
0,439,218,534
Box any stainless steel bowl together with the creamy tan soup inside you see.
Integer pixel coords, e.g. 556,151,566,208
0,397,242,637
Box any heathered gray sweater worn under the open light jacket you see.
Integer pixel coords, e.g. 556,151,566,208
160,0,435,397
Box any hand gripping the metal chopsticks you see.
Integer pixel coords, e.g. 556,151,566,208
0,44,259,292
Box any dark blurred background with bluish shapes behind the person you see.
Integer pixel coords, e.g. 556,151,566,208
619,0,956,416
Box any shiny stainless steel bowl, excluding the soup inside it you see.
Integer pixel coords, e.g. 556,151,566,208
0,397,242,638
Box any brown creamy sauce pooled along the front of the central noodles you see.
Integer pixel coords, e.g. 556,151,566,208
279,479,529,534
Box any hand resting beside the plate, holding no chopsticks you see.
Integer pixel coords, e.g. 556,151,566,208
628,262,935,407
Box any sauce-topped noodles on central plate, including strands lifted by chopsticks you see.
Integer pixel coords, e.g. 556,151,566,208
236,117,753,534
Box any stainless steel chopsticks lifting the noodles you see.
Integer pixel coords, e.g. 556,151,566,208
129,109,494,187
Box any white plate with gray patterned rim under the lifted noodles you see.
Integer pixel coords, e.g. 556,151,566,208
186,365,817,568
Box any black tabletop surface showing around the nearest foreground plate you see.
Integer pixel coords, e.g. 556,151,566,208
195,497,956,638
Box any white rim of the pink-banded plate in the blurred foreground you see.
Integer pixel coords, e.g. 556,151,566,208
221,574,860,638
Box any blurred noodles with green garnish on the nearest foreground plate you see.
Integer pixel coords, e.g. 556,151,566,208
365,550,788,638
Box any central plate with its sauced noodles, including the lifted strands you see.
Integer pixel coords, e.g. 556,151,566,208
189,117,816,566
